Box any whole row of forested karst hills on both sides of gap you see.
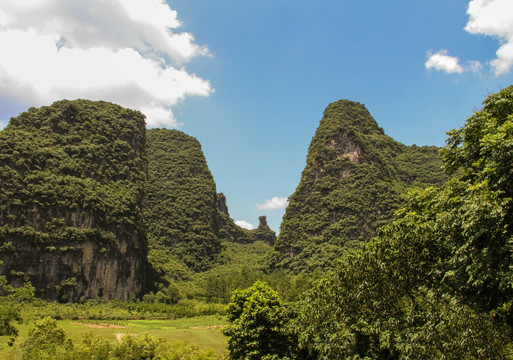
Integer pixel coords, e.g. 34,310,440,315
0,96,445,301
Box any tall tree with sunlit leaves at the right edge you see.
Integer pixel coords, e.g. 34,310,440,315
441,86,513,316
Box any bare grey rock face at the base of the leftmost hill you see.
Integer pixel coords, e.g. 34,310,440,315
0,237,146,301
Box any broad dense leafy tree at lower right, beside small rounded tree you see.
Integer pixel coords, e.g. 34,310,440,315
293,218,509,360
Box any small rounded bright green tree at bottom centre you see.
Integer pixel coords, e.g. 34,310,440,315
224,281,290,360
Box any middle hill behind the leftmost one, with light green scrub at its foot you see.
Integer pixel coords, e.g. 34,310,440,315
144,129,276,302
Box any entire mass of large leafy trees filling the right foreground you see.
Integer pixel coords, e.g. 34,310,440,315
294,86,513,359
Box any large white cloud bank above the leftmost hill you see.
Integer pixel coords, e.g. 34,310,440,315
0,0,212,127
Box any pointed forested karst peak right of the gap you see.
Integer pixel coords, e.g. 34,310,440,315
271,100,445,272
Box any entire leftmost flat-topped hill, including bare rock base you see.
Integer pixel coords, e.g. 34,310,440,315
0,100,147,301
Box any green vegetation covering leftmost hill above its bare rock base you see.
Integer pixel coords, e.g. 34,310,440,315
0,100,145,245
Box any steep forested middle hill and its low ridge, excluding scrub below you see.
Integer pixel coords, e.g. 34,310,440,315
144,129,275,288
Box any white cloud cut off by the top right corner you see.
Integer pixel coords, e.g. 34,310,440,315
465,0,513,75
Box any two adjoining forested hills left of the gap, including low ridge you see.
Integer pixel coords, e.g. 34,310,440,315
0,105,276,301
